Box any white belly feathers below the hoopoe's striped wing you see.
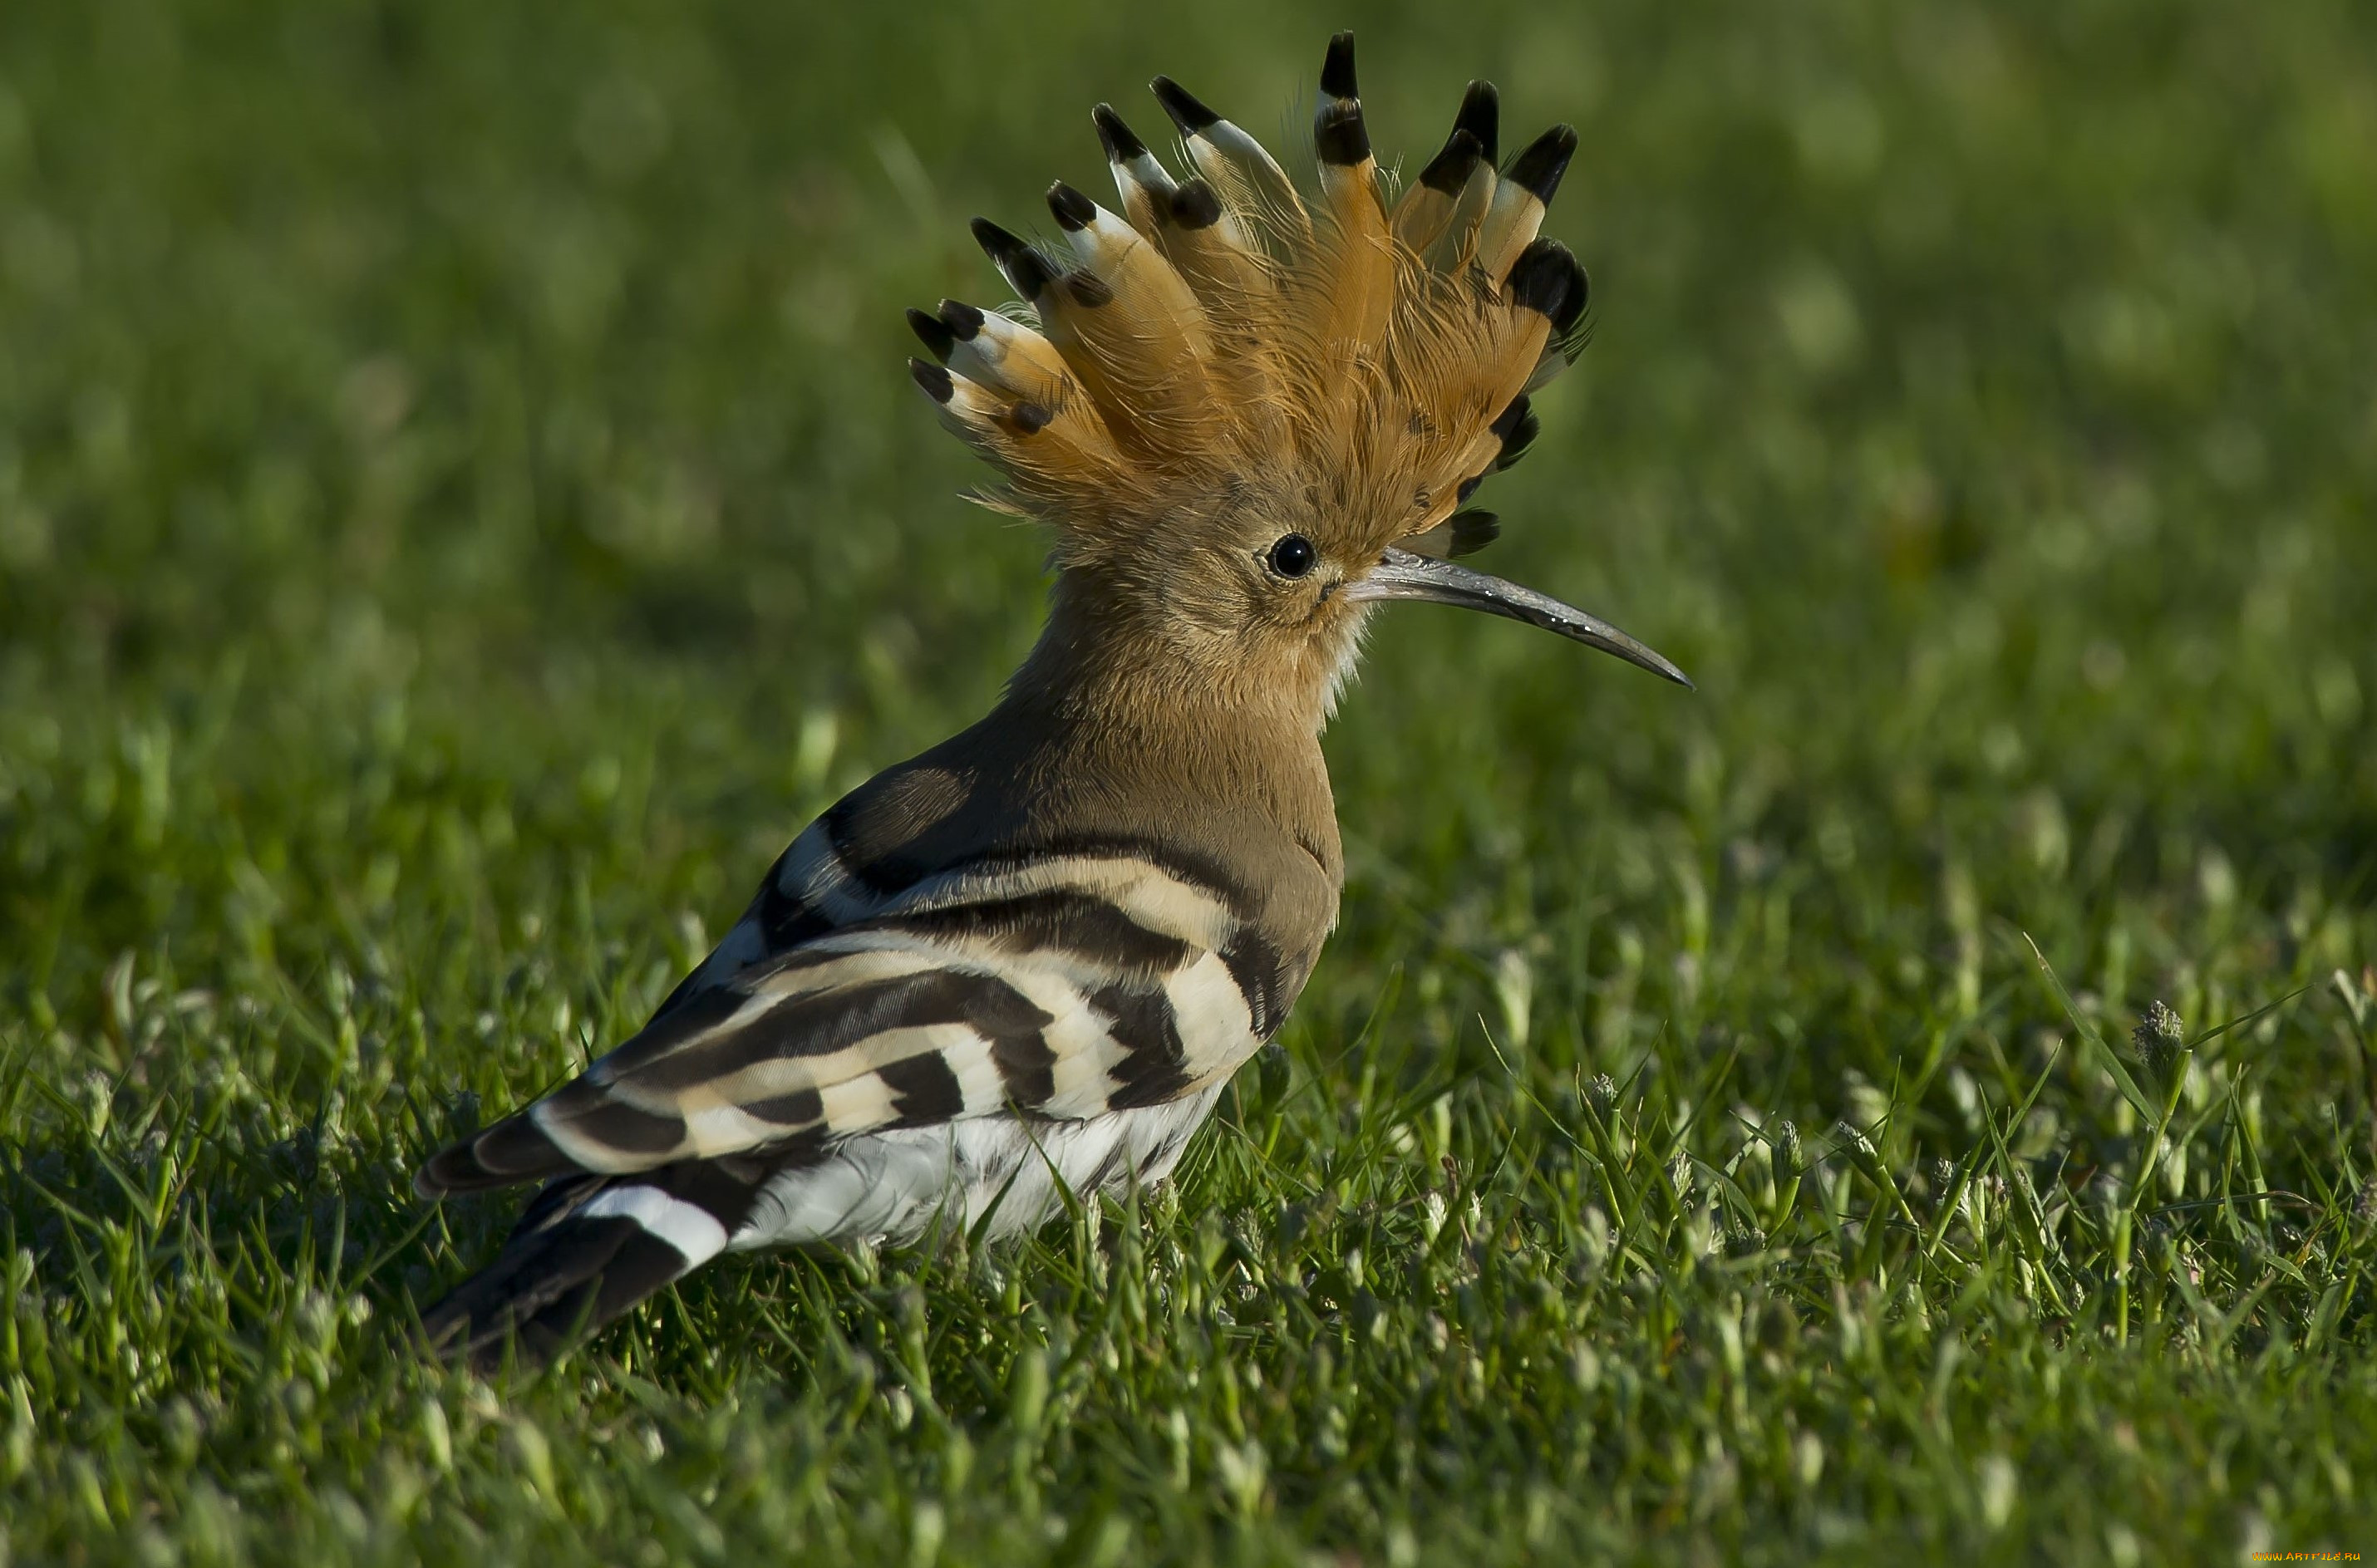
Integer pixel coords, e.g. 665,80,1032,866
727,1084,1222,1252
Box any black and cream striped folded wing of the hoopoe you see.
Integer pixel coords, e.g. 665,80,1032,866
418,818,1282,1192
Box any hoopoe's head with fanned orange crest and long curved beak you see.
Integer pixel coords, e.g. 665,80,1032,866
908,33,1690,722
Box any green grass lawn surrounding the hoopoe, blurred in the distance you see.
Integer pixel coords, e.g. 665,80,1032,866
0,0,2377,1566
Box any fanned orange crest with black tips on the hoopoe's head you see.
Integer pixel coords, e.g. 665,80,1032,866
910,33,1586,561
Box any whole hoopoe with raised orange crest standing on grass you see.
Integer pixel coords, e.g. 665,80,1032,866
416,33,1690,1361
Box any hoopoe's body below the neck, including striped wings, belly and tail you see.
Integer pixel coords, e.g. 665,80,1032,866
418,689,1338,1352
